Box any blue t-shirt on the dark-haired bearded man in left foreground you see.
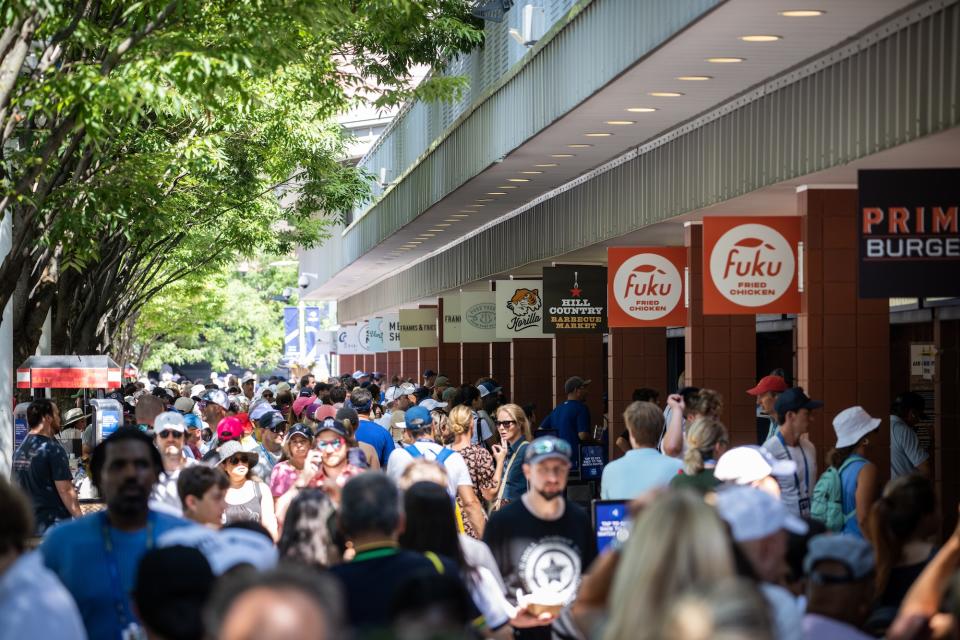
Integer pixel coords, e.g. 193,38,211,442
40,511,200,640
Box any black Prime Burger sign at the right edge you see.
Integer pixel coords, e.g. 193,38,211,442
857,169,960,298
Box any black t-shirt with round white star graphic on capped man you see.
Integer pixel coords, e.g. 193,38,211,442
483,500,597,638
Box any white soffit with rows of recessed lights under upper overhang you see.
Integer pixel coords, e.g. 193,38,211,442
306,0,914,300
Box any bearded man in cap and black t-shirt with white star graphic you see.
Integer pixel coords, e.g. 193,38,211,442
483,436,596,639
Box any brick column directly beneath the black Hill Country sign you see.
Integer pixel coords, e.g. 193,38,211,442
544,333,606,427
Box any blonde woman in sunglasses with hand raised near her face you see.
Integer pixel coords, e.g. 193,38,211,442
483,404,533,510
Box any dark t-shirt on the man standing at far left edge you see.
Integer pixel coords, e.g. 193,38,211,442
13,434,73,535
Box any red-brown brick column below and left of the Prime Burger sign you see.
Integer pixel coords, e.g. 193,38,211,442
797,189,890,482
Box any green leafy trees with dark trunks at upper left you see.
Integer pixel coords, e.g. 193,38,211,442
0,0,482,362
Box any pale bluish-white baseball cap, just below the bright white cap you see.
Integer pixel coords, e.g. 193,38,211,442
717,487,808,542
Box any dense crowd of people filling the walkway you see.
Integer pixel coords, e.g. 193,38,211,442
0,371,960,640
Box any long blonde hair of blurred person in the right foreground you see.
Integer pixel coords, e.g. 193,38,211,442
603,491,735,640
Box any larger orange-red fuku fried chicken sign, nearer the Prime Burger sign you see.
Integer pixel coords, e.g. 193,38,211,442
703,216,800,315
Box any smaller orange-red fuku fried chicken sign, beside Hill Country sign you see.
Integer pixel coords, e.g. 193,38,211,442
607,247,687,327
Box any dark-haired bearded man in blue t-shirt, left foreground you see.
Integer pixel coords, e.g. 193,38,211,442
40,427,197,638
